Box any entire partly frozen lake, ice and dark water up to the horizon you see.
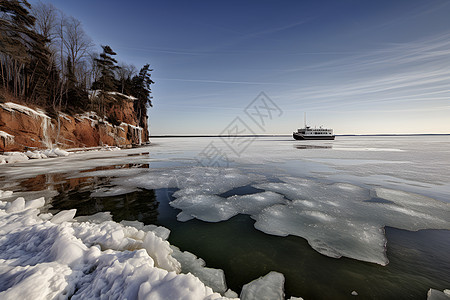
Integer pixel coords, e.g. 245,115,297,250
0,136,450,299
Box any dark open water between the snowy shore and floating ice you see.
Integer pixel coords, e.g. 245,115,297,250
15,165,450,299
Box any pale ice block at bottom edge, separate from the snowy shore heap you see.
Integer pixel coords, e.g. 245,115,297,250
241,271,284,300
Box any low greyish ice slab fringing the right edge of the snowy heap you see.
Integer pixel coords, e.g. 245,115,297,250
172,246,229,292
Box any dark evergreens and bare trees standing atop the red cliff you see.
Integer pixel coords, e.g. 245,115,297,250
0,0,154,126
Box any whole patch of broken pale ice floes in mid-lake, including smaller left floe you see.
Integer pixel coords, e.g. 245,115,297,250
166,173,450,265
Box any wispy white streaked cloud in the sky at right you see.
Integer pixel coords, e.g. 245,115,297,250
289,33,450,109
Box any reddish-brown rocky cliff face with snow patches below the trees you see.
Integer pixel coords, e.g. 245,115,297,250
0,100,149,151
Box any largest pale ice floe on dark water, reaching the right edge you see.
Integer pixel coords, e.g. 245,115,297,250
253,177,450,265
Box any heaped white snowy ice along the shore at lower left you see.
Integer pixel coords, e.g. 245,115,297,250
0,192,232,299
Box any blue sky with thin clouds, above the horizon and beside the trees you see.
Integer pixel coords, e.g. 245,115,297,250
30,0,450,135
